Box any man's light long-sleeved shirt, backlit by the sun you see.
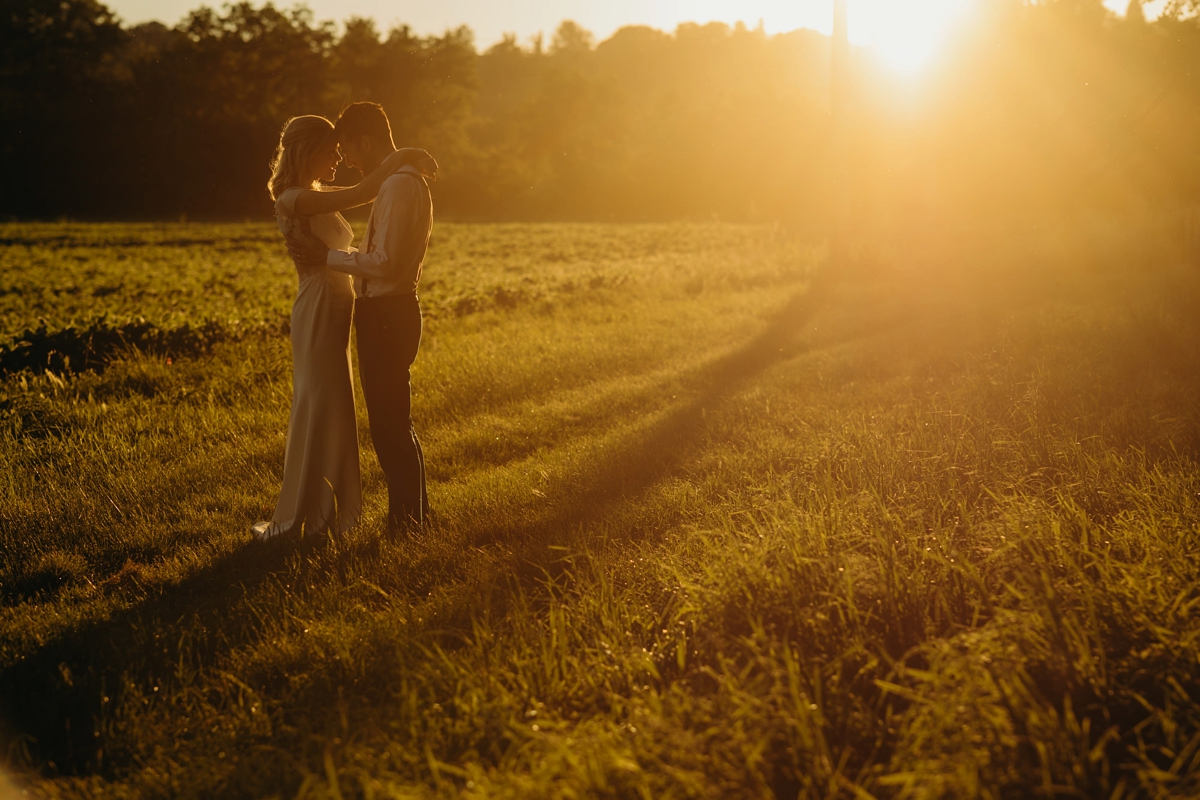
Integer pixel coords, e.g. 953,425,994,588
325,167,433,297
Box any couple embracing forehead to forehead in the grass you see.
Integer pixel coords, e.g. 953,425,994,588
251,103,437,540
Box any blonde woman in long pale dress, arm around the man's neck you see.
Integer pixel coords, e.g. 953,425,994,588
251,115,437,540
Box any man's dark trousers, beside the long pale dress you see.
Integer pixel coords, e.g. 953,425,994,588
354,294,430,527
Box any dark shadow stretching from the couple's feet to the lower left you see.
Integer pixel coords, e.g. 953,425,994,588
0,527,438,775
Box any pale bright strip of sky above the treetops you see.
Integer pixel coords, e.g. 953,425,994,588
107,0,1165,66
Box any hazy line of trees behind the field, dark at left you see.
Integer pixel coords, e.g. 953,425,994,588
0,0,1200,225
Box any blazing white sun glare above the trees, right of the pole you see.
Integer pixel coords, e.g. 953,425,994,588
850,0,971,74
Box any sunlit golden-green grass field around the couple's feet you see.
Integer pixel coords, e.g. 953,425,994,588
0,217,1200,799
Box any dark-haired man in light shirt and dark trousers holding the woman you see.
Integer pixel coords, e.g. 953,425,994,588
293,103,437,533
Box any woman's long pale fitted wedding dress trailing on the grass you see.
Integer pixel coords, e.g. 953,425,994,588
251,188,362,539
